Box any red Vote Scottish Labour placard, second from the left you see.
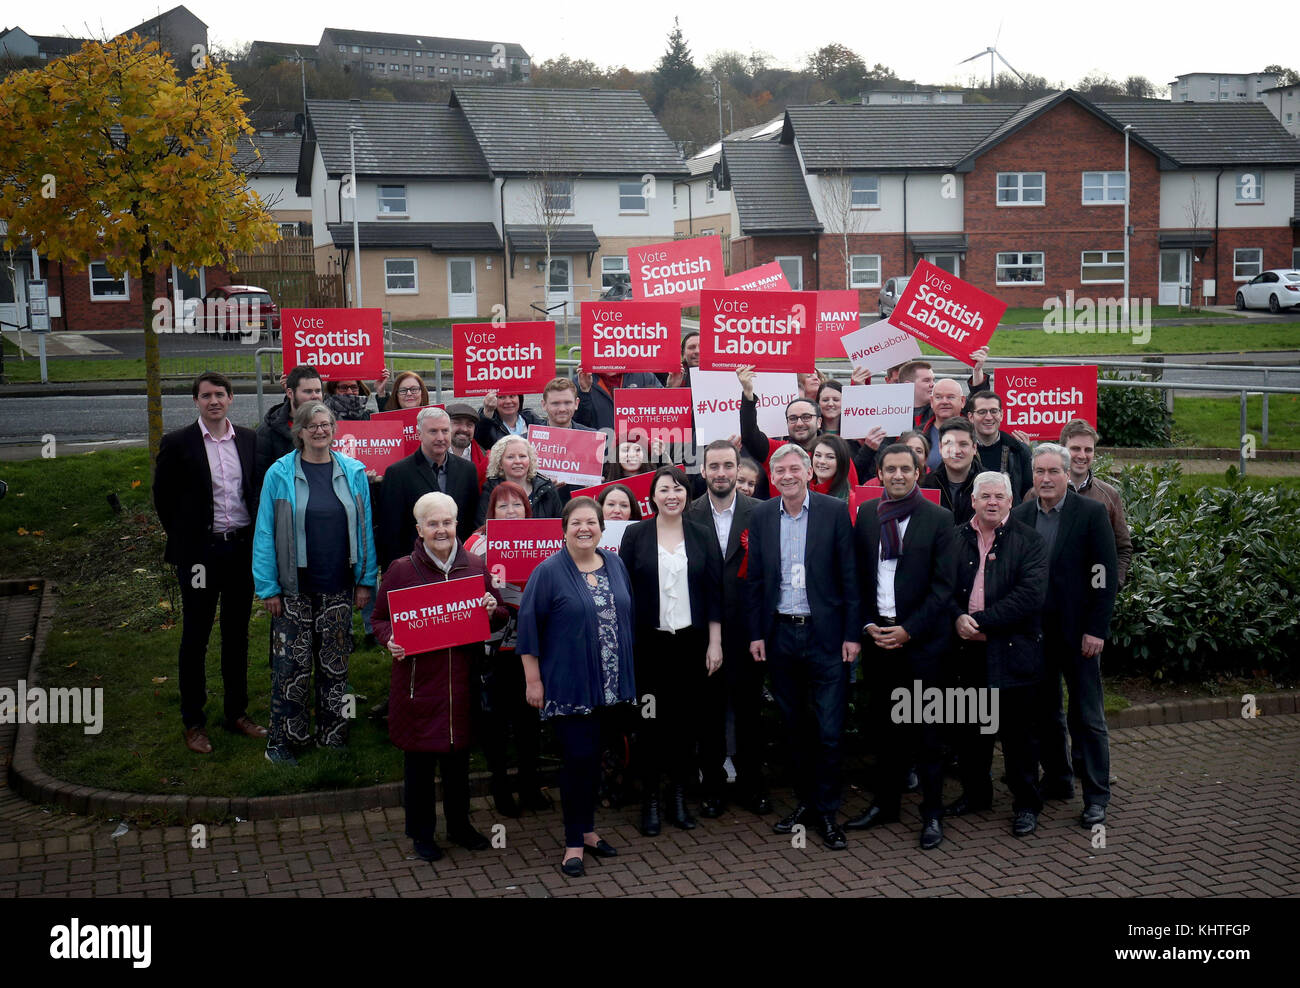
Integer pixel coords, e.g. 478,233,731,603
451,321,555,395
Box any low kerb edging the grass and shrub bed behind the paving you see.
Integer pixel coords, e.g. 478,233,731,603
0,580,1300,822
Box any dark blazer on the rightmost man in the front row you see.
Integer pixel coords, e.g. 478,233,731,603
1011,490,1119,655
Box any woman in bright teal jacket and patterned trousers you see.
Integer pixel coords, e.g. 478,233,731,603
252,402,377,764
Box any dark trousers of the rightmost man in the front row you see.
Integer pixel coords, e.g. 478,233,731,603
1040,637,1110,806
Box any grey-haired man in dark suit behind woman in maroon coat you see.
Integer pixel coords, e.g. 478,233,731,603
374,408,478,569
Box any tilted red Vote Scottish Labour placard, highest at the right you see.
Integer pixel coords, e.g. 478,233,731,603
889,260,1006,367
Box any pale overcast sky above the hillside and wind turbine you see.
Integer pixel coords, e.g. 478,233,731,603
20,0,1300,95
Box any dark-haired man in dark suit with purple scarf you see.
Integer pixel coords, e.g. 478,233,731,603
845,443,953,850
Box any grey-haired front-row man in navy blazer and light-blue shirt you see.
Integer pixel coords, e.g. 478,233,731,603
746,443,862,850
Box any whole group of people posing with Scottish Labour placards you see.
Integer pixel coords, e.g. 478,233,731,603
153,334,1132,875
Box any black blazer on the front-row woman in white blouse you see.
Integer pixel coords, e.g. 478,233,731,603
619,517,723,638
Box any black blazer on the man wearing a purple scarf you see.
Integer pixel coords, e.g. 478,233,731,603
853,499,953,659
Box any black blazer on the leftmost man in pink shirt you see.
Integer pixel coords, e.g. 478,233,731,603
153,423,261,566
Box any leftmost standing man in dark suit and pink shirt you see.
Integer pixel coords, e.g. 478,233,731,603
153,371,267,754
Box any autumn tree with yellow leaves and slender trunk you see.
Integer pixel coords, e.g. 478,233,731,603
0,35,278,456
